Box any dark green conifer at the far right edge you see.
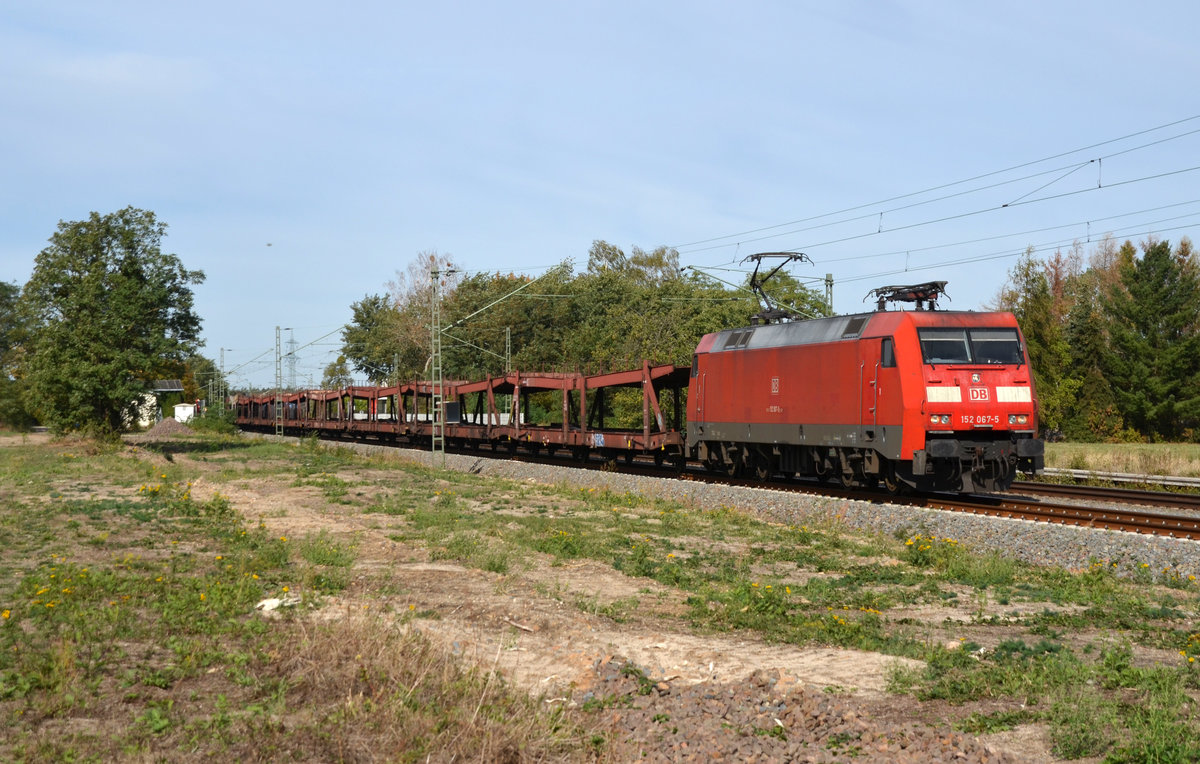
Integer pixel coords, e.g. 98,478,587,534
1104,239,1200,440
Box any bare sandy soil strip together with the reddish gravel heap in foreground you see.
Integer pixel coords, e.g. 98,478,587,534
176,456,1065,762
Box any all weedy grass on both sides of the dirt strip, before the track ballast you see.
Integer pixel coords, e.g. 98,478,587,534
0,437,1200,762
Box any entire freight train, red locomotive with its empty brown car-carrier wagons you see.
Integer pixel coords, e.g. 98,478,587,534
235,282,1043,492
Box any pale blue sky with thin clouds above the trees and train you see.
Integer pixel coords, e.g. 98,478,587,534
0,0,1200,385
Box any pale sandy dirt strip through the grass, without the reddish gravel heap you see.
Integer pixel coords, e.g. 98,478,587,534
129,438,1080,762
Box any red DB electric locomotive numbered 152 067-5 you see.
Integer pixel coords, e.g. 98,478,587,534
688,282,1043,492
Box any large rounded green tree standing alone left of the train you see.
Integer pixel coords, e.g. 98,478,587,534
20,207,204,435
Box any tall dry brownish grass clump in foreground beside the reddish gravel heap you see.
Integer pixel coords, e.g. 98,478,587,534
274,616,584,763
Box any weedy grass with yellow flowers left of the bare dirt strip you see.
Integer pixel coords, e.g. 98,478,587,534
0,434,582,762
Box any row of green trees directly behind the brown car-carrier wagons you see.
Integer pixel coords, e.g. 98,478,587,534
322,241,828,387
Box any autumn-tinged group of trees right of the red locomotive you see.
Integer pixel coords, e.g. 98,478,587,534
991,237,1200,441
